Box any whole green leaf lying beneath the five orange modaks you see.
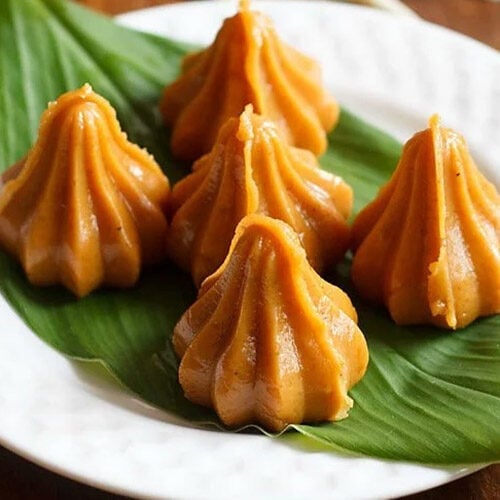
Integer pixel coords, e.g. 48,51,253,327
0,0,500,464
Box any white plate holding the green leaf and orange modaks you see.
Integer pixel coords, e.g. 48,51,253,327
0,1,500,498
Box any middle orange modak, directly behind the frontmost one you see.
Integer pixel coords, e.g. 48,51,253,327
168,105,353,285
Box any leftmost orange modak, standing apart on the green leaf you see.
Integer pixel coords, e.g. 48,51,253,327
0,85,169,296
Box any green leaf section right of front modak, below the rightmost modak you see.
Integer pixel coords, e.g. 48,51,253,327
295,304,500,463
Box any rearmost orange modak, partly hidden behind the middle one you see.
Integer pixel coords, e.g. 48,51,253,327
160,1,339,160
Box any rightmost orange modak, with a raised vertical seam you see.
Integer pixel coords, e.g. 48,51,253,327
352,115,500,329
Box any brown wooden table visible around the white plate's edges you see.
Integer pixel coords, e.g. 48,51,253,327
0,0,500,500
